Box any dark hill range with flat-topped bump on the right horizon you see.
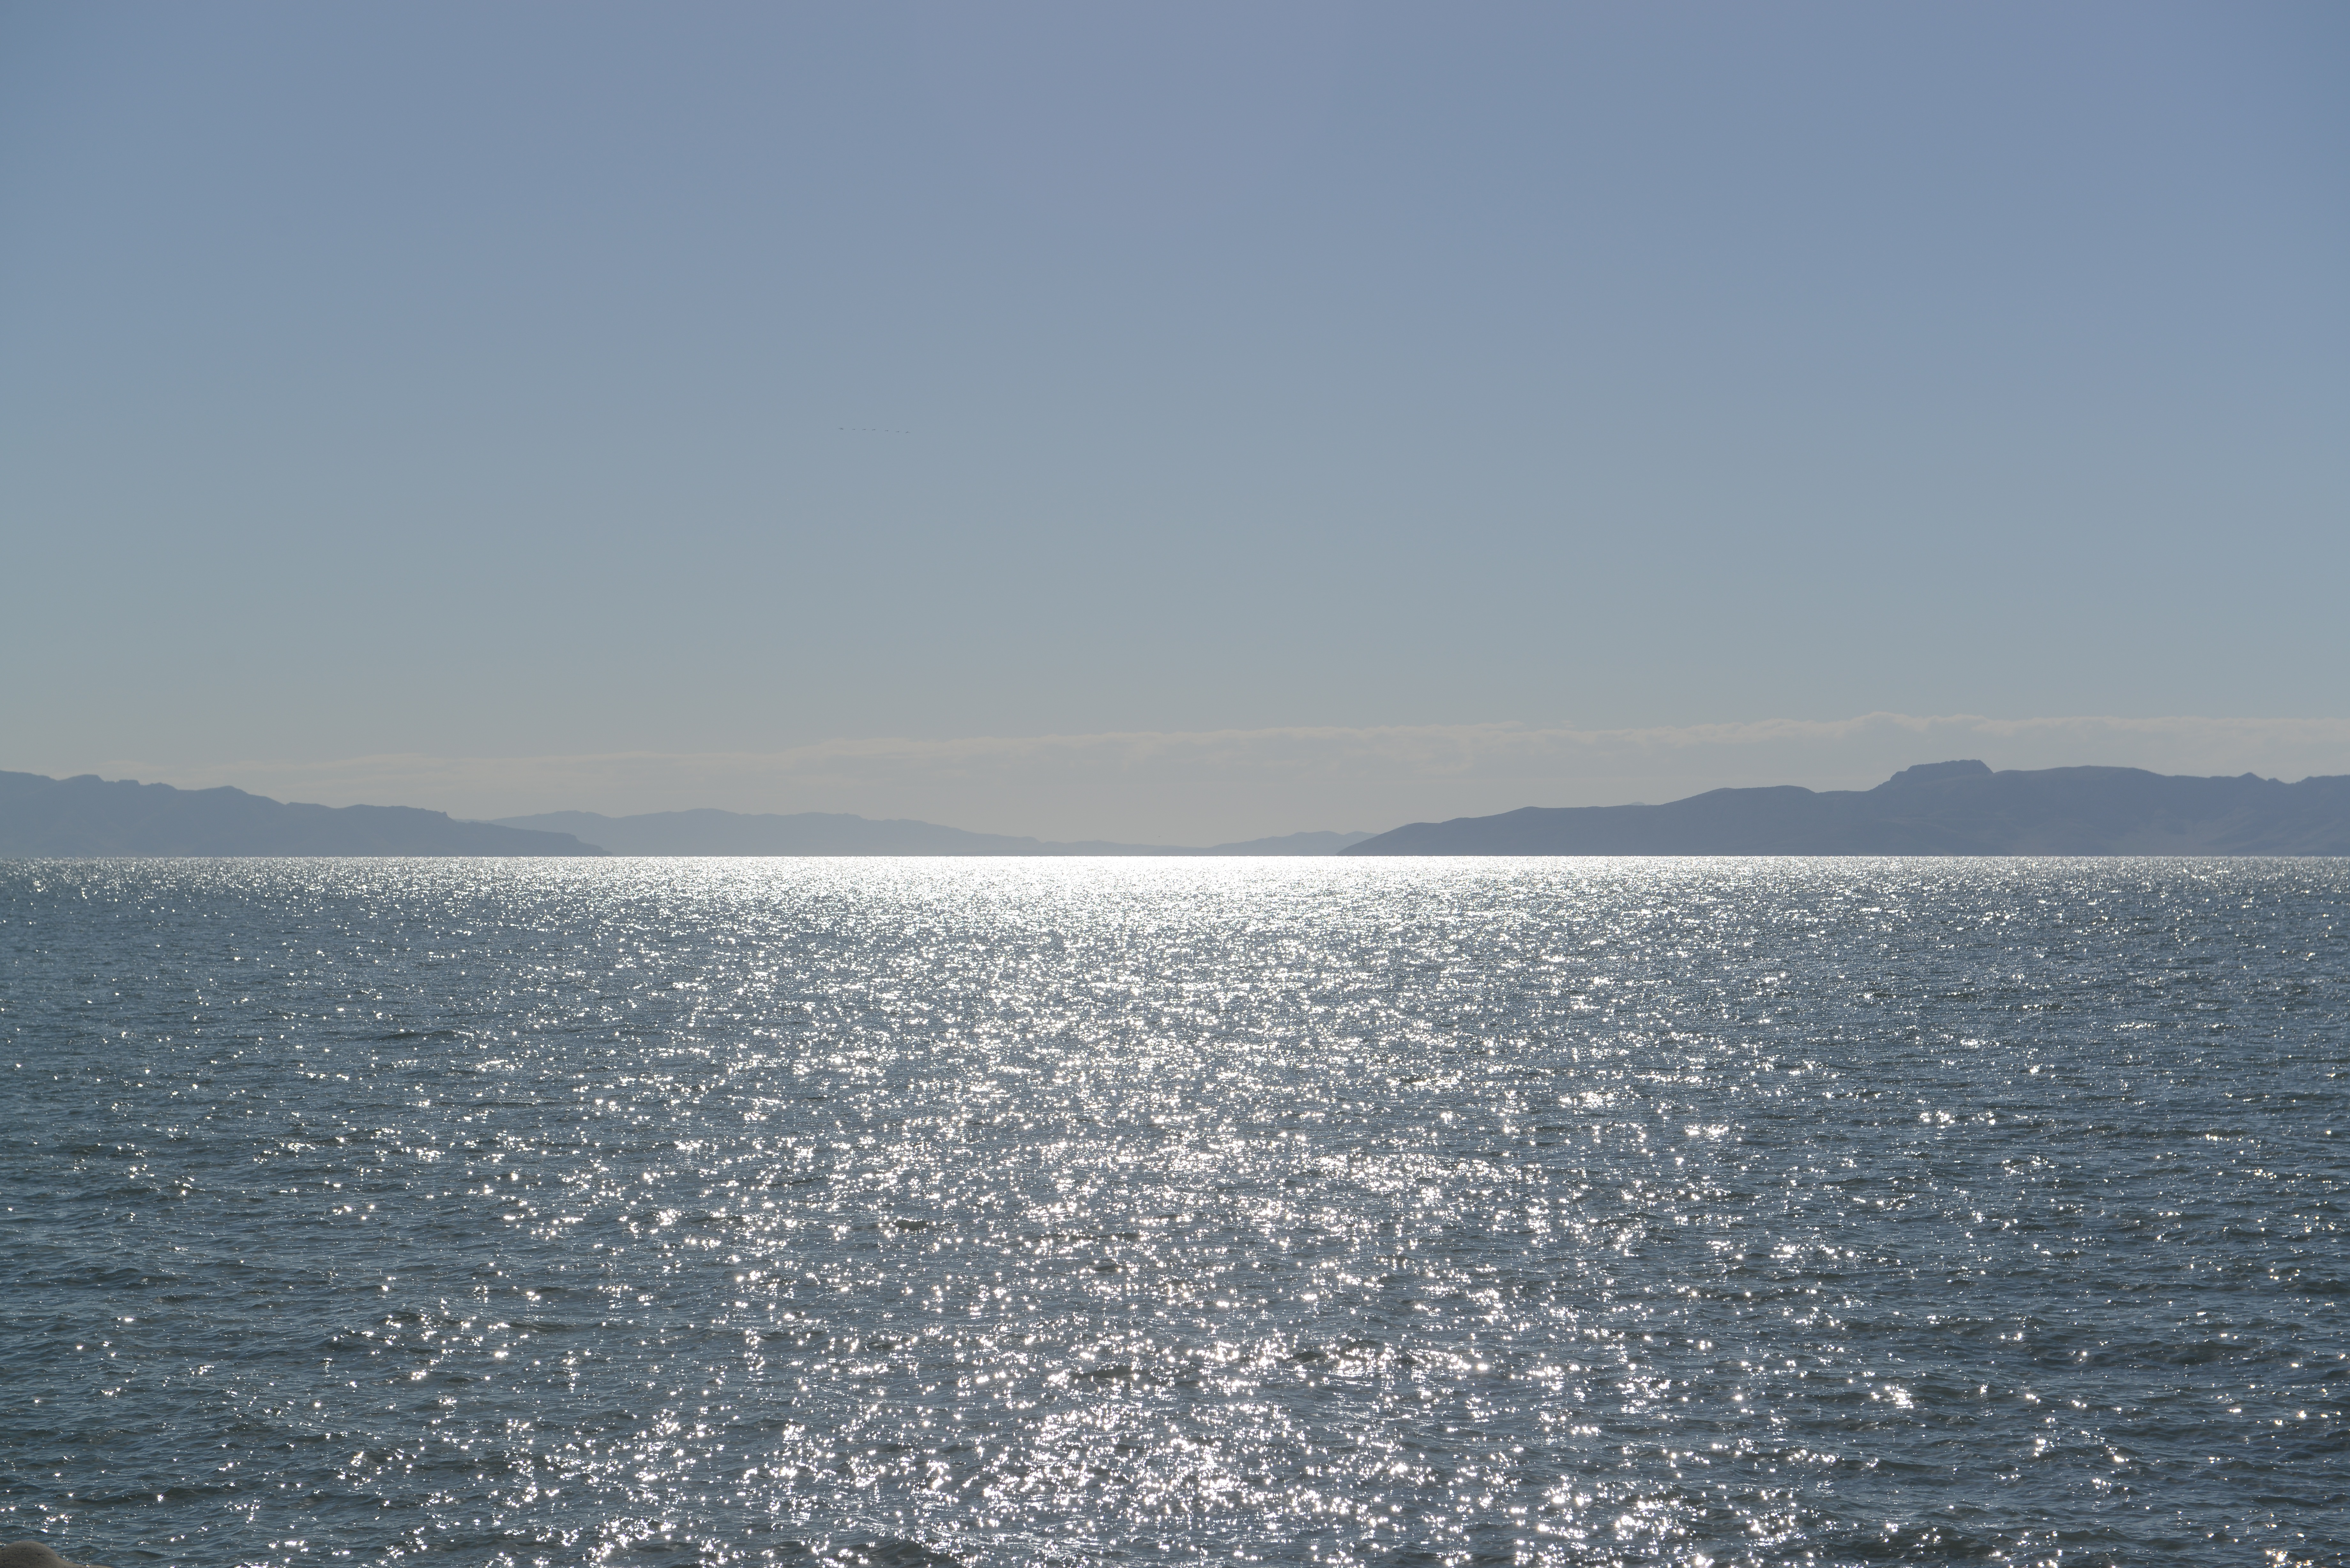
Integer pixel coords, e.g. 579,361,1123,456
1344,762,2350,856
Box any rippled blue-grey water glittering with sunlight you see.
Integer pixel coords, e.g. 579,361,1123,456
0,860,2350,1568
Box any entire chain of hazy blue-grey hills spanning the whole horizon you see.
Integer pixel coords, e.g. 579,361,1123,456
0,762,2350,858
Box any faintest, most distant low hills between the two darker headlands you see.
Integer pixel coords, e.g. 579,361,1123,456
498,811,1370,856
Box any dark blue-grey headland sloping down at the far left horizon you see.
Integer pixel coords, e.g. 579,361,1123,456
0,773,602,858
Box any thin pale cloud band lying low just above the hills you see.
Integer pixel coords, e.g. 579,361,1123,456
69,712,2350,844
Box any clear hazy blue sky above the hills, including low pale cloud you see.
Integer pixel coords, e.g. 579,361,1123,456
0,0,2350,841
